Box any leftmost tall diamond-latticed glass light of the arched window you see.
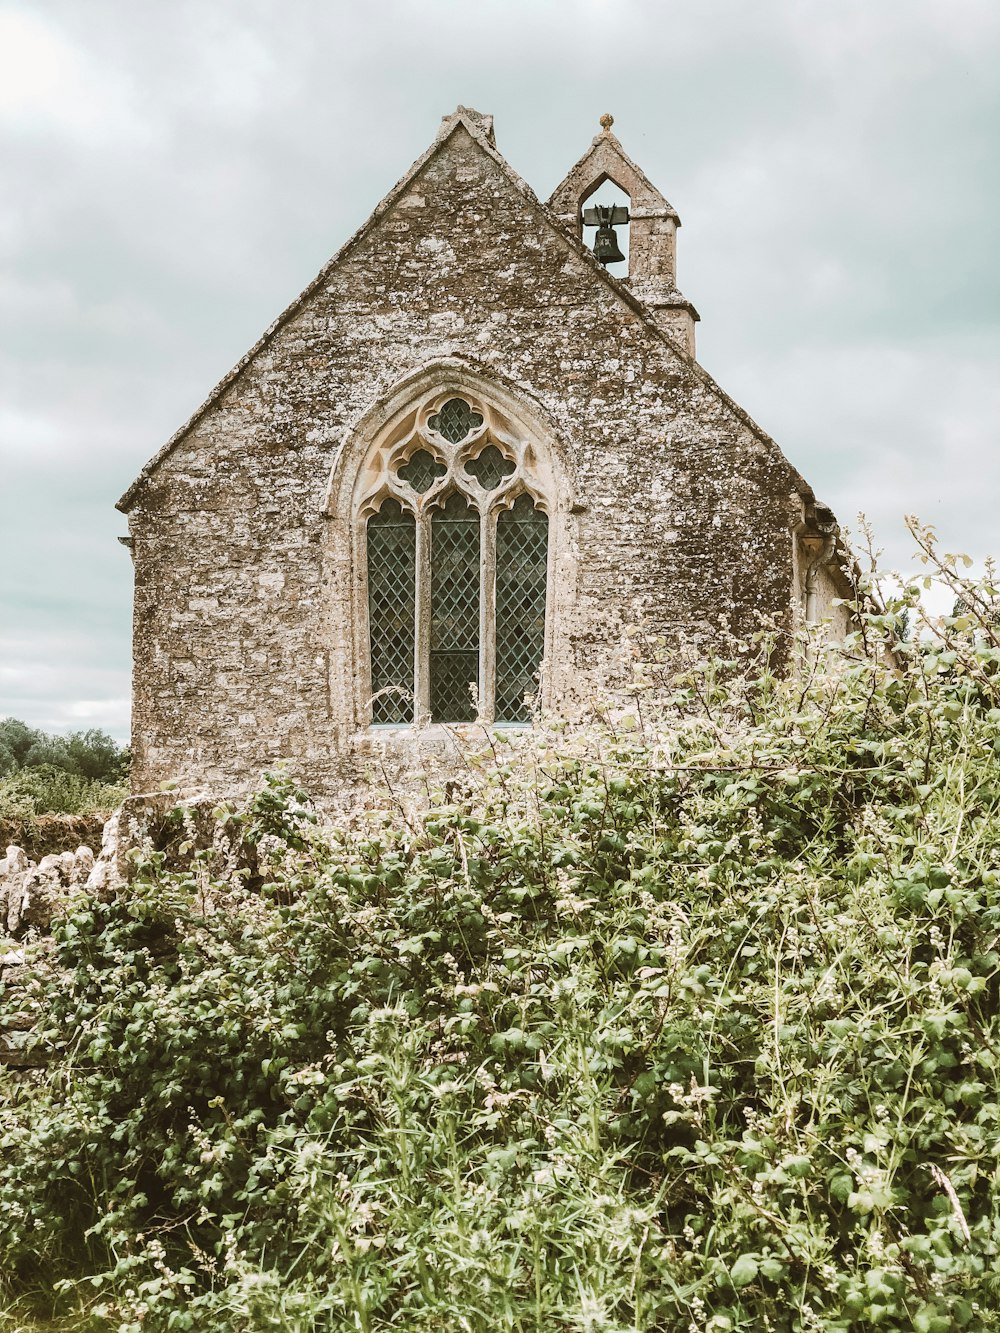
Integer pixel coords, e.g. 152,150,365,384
368,500,416,722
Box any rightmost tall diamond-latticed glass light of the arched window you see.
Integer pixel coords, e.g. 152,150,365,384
496,496,548,722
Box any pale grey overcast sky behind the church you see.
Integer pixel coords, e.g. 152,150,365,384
0,0,1000,738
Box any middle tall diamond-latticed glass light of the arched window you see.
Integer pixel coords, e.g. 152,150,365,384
431,495,480,722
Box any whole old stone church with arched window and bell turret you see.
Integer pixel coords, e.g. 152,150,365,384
119,107,851,796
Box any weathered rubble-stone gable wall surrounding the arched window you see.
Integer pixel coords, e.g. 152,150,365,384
123,116,837,794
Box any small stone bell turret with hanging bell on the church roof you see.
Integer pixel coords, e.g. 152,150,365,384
548,115,699,359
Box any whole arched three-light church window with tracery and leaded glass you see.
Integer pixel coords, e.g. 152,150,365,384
363,395,549,725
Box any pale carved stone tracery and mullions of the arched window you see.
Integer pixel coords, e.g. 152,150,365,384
352,385,556,730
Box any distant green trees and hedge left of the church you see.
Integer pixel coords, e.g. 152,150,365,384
0,717,131,821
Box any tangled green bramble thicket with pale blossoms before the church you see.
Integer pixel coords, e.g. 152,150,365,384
0,525,1000,1333
